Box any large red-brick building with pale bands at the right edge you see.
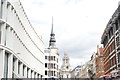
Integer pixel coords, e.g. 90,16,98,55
101,2,120,74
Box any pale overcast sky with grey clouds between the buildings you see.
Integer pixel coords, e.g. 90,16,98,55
21,0,119,68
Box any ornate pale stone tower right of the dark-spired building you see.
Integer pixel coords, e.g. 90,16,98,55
60,53,71,78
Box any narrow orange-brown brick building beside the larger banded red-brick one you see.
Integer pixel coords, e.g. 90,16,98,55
96,46,104,78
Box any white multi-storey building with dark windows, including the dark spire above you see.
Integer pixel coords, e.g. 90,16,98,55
45,17,59,78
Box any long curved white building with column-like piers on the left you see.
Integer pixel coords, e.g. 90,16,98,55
0,0,45,78
